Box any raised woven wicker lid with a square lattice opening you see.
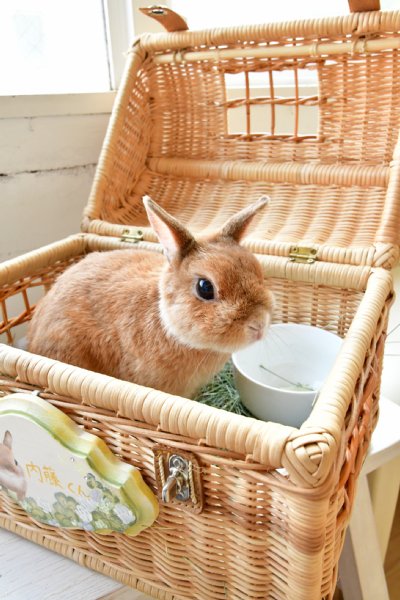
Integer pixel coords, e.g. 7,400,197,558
83,12,400,268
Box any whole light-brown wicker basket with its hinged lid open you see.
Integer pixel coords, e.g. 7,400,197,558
0,5,400,600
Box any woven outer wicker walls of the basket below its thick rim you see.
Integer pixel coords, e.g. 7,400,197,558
0,324,388,600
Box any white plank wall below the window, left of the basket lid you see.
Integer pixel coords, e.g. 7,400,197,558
0,93,114,261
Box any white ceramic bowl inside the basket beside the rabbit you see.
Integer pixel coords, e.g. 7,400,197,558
232,323,343,427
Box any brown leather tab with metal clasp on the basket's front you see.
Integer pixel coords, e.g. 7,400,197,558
153,445,204,514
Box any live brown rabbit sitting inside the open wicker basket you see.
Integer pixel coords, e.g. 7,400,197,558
28,197,272,397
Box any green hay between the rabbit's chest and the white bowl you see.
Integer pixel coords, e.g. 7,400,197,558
194,361,255,418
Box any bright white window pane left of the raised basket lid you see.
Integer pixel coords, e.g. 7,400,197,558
0,0,110,95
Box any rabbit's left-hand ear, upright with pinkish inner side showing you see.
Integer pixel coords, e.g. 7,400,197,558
143,196,196,262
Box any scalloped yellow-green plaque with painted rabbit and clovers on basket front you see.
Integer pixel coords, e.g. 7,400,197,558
0,394,158,535
